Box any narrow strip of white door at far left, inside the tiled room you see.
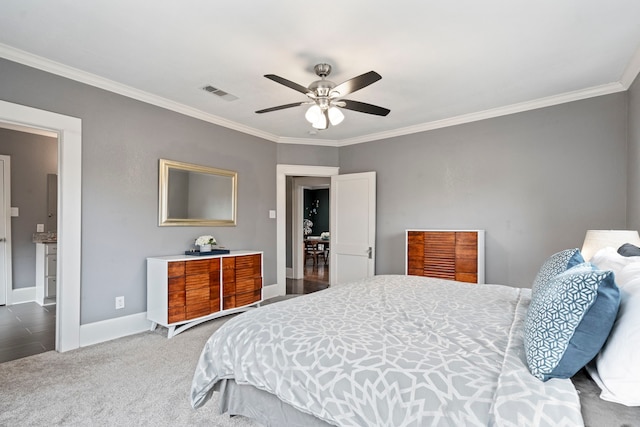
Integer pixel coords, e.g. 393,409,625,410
0,156,11,305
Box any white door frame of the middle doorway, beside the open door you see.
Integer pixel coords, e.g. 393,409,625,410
276,164,340,299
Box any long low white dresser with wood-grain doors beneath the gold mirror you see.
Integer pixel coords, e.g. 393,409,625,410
147,251,262,338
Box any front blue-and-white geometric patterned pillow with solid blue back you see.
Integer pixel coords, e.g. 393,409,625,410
524,263,620,381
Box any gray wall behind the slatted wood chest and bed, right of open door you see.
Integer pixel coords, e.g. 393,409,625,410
340,93,627,287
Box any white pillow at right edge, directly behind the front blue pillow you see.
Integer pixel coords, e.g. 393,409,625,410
587,276,640,406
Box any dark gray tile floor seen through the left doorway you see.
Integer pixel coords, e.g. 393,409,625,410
0,302,56,363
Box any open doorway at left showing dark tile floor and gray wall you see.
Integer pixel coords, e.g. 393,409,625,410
0,129,58,362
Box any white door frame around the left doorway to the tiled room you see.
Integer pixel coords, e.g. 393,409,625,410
0,101,82,352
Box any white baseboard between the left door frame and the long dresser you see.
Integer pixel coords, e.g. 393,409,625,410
80,312,151,347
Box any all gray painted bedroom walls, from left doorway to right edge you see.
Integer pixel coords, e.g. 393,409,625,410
0,55,640,324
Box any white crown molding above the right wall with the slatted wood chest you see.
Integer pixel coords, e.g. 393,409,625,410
339,83,626,147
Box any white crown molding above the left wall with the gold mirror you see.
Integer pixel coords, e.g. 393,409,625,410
0,43,279,142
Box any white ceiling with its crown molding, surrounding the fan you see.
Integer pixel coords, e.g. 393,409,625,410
0,0,640,146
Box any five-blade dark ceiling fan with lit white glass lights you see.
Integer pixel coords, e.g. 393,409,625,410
256,64,391,129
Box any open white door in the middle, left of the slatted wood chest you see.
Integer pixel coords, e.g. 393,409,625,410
329,172,376,286
